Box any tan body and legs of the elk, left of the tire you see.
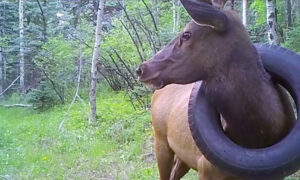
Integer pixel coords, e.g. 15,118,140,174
152,84,241,180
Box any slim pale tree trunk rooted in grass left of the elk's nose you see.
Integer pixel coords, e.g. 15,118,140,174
90,0,104,121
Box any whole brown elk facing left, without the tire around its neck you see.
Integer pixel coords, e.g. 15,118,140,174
137,0,295,180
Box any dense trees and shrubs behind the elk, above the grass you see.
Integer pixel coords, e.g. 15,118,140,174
0,0,300,109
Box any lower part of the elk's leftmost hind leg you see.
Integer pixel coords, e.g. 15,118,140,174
154,135,174,180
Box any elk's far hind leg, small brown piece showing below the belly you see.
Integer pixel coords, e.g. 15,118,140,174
170,155,190,180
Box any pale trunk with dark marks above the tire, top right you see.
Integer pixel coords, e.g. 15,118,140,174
266,0,279,45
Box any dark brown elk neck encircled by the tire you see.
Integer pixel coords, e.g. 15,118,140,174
204,45,290,148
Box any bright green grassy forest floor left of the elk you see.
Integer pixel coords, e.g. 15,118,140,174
0,89,300,180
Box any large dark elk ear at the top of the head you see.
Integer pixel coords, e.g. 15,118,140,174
181,0,228,32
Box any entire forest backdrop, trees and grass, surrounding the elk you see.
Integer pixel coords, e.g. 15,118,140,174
0,0,300,180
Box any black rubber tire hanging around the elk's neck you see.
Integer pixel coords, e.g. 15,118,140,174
188,44,300,180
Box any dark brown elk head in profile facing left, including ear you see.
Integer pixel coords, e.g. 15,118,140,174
137,0,251,89
